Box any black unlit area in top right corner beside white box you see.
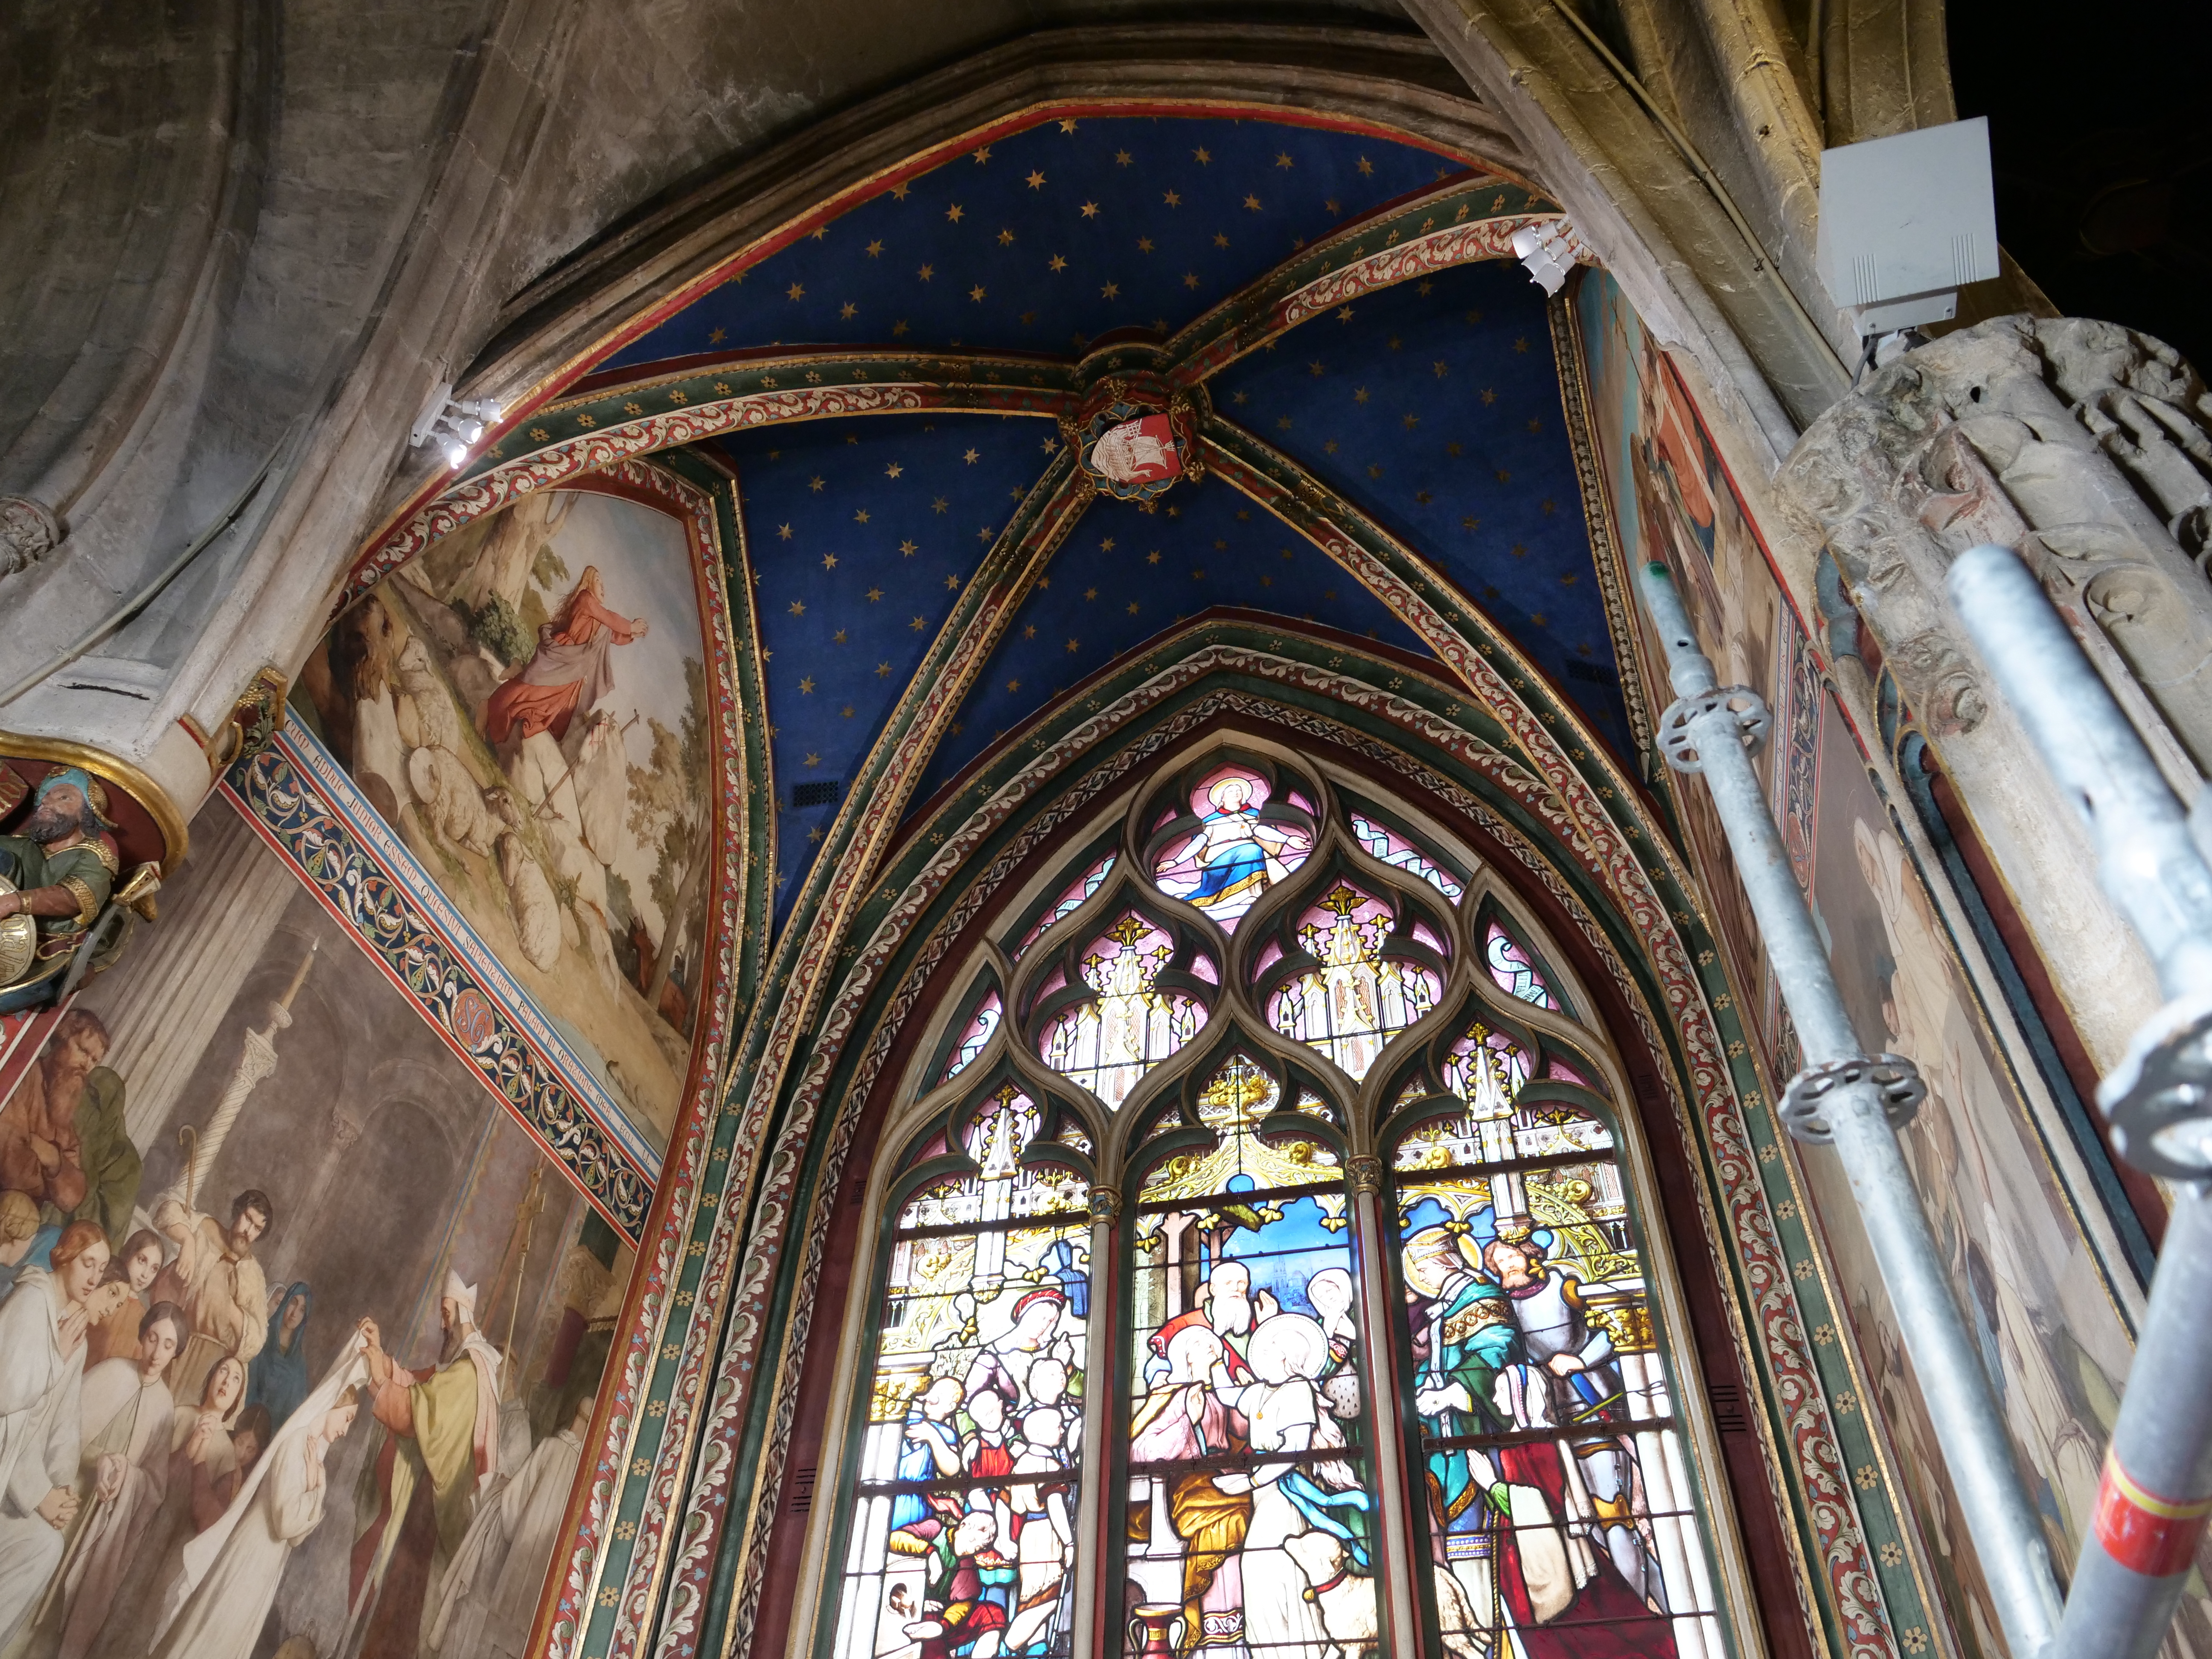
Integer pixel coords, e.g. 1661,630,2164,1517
1947,0,2212,374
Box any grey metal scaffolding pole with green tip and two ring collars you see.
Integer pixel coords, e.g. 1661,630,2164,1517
1642,564,2070,1659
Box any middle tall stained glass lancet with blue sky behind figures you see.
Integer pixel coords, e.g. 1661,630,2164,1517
1123,1055,1378,1659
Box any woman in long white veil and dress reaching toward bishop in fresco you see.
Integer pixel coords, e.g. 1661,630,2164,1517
153,1332,370,1659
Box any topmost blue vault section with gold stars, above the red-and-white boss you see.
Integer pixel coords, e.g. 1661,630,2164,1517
600,117,1464,370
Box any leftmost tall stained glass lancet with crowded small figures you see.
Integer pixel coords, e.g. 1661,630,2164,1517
836,1084,1091,1659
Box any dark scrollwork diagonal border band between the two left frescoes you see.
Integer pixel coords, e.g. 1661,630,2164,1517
221,739,655,1246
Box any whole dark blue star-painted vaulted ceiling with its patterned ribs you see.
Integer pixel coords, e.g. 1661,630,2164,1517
449,102,1628,938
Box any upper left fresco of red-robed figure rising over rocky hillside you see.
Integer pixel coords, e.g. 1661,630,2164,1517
294,484,717,1148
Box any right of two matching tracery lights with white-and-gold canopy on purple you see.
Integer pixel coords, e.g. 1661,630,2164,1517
1267,880,1444,1077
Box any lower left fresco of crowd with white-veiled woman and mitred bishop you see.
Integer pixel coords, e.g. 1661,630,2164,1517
0,801,630,1659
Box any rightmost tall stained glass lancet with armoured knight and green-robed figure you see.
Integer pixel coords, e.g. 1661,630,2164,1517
1394,1039,1723,1659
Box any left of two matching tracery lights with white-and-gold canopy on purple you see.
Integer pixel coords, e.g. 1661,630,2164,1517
1037,911,1205,1106
